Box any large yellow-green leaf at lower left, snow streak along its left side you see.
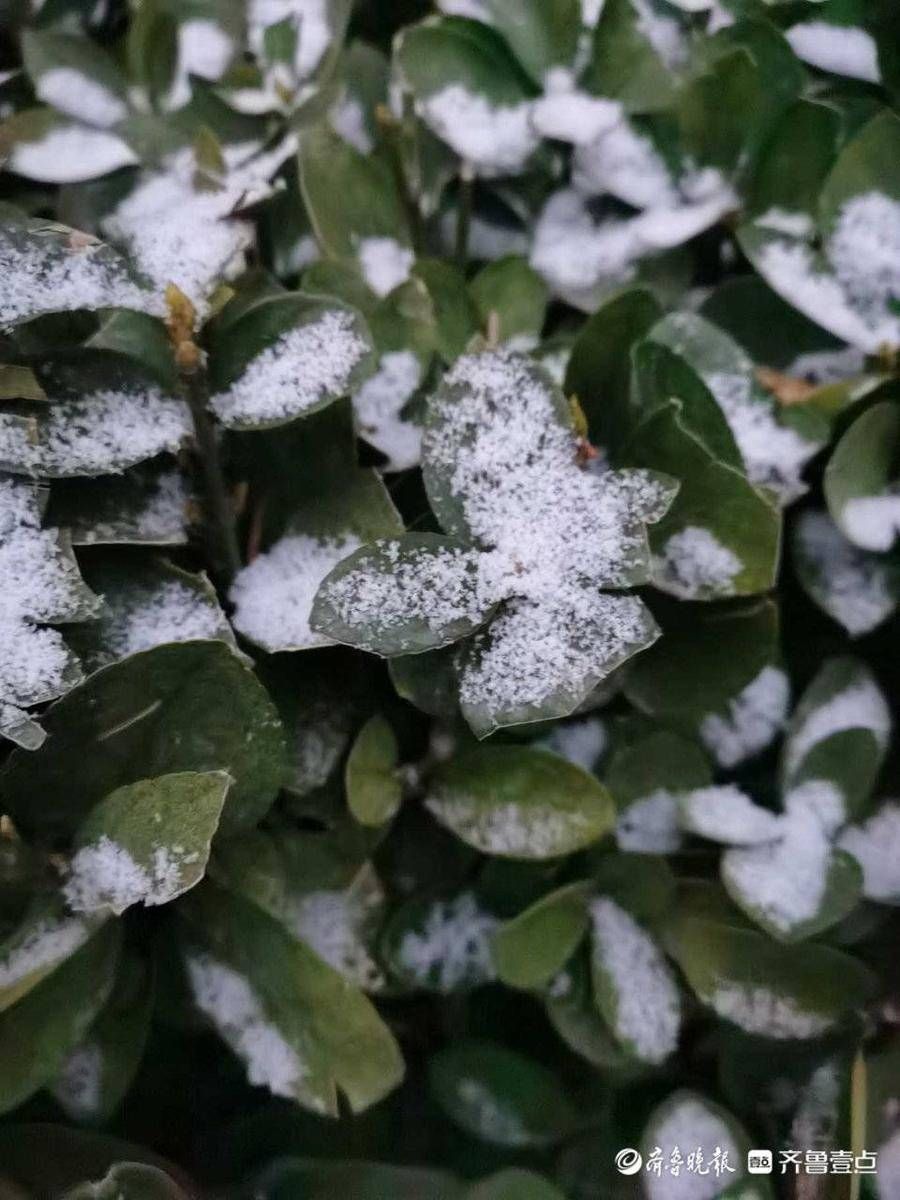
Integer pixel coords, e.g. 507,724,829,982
179,883,403,1116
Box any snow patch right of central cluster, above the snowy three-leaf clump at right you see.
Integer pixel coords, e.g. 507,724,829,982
700,666,791,767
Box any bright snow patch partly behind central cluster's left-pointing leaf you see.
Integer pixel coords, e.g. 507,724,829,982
230,533,362,650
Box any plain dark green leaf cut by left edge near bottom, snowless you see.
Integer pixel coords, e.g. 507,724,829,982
0,923,121,1112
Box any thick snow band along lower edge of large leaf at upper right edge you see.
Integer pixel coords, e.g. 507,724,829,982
758,230,900,354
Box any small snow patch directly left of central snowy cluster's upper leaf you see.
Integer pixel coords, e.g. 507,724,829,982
353,350,422,470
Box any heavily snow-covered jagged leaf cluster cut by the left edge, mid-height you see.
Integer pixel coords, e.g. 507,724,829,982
0,478,97,745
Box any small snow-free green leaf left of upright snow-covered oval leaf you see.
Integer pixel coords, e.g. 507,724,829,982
493,883,589,990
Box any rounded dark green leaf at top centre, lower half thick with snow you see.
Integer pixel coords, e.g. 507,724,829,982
395,17,539,175
